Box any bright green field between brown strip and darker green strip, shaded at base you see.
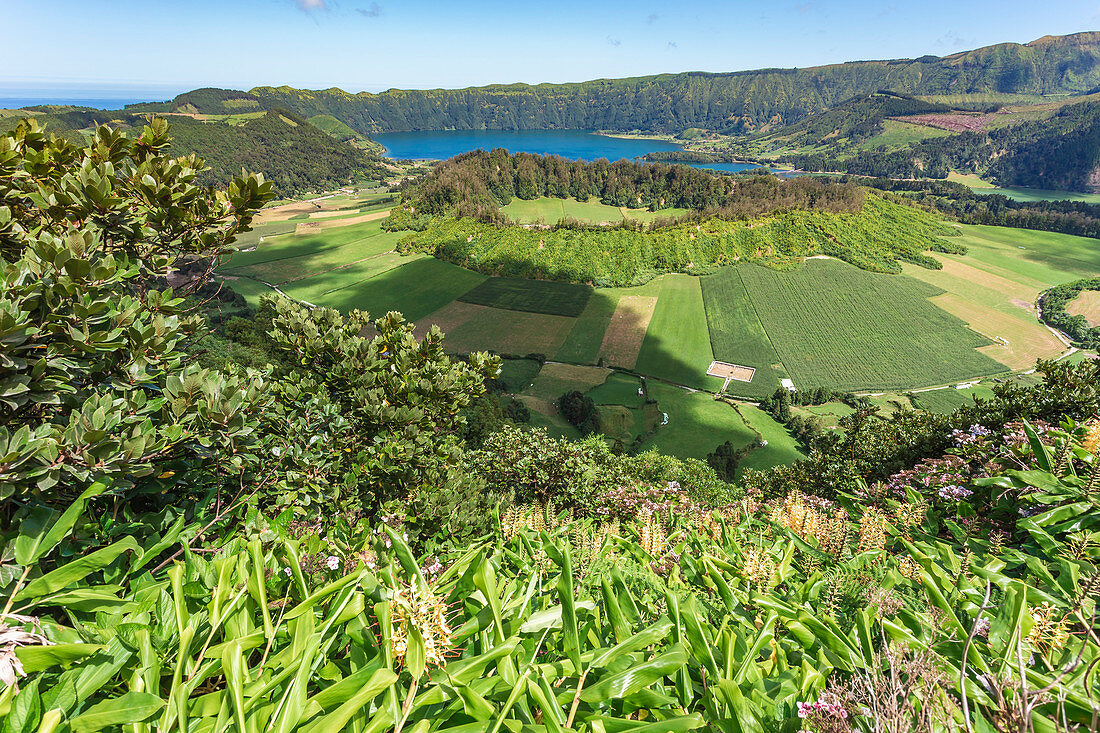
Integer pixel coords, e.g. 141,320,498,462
631,274,722,387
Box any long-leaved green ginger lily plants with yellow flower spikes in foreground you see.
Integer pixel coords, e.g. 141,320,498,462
0,425,1100,733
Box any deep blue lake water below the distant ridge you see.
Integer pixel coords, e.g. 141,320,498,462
372,130,770,173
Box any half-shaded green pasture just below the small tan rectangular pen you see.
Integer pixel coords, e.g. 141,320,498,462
642,380,756,459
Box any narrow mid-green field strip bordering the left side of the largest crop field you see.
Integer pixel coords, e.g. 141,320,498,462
701,267,787,397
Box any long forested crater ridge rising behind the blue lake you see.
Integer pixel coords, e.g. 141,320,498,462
135,32,1100,134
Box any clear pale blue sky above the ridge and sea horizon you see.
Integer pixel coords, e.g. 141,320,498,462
0,0,1100,96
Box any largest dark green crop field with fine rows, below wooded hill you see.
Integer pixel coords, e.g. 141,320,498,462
740,260,1007,390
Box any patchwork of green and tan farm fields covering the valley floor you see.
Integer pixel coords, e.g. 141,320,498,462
221,191,1100,469
